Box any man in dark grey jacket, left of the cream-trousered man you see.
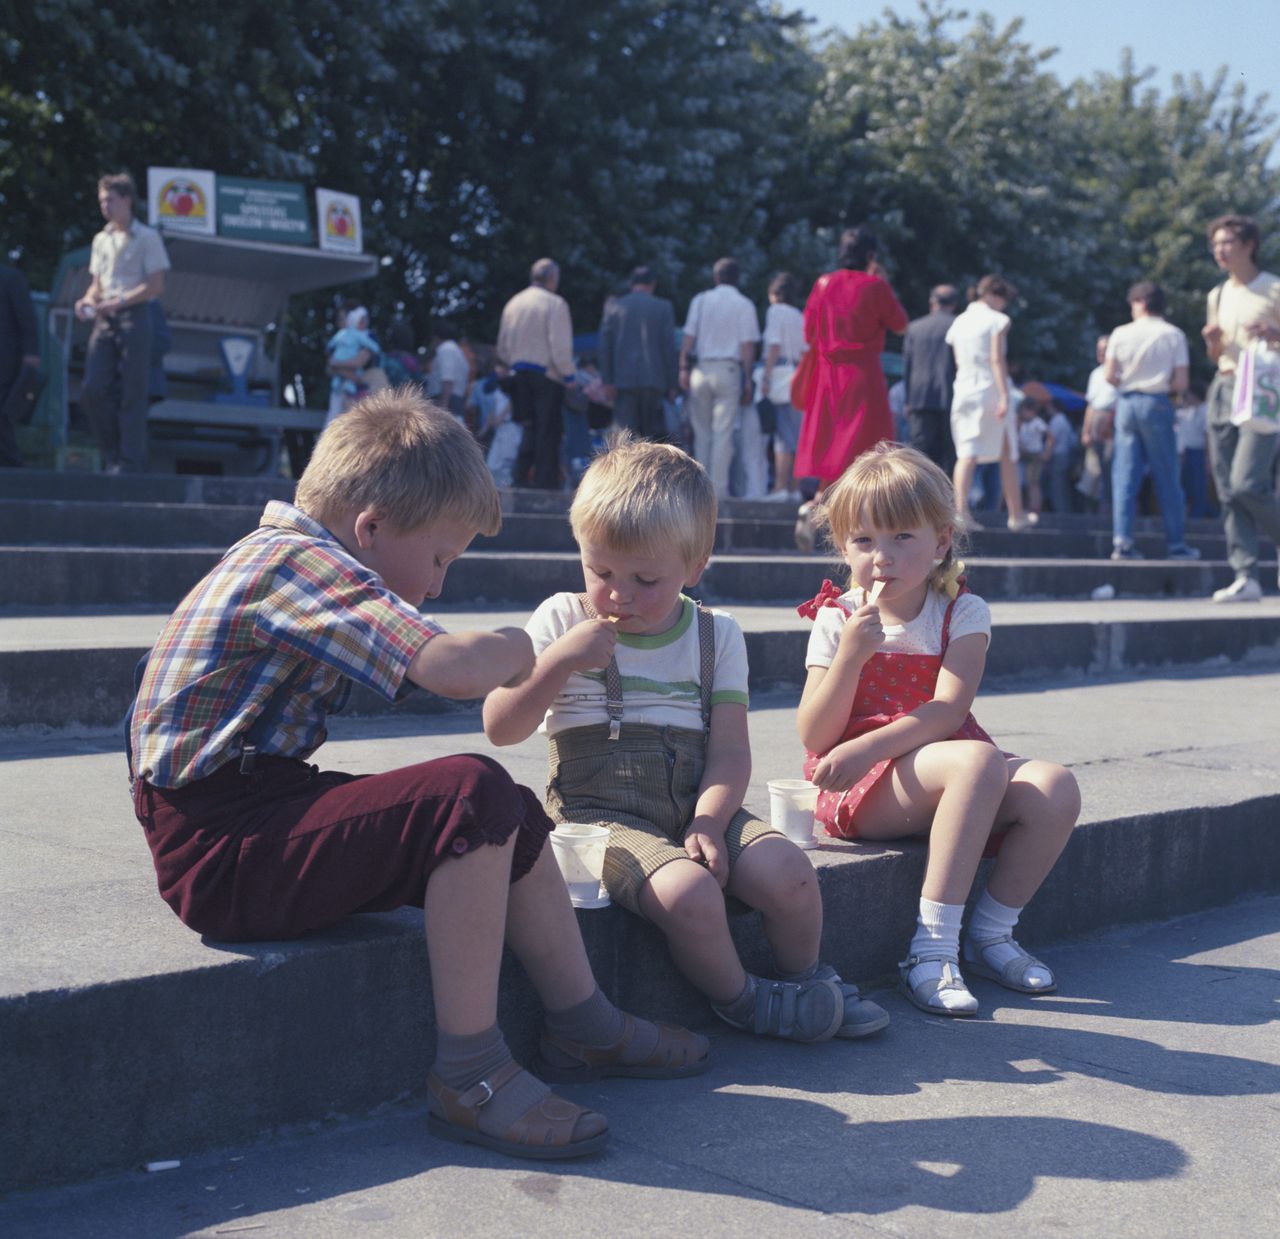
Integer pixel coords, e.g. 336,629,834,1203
600,266,677,443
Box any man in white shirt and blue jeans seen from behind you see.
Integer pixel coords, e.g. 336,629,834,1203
1105,280,1199,559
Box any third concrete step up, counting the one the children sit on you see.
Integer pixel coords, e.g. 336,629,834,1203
0,545,1249,611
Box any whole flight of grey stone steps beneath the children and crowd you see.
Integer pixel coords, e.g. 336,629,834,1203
0,471,1280,1189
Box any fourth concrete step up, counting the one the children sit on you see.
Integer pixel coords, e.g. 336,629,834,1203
0,499,1244,559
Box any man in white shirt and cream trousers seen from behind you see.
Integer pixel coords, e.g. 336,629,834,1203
680,259,760,499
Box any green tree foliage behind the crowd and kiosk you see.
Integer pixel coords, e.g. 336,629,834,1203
0,0,1280,391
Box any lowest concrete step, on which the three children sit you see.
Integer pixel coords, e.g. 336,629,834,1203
0,671,1280,1189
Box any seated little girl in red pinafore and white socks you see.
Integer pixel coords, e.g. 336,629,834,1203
799,443,1080,1015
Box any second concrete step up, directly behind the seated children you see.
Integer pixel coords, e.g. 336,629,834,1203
0,598,1280,728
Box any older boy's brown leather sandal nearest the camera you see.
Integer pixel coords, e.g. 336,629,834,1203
426,1061,609,1161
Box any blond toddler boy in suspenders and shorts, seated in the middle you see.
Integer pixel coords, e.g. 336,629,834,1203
484,434,888,1042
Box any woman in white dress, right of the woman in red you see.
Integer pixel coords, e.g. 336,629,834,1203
947,275,1036,530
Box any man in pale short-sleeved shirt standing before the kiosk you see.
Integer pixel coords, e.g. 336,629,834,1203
76,173,169,474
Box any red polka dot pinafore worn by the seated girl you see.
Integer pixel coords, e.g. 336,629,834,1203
801,582,996,838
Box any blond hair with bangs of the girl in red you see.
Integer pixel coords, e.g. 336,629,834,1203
817,442,964,598
